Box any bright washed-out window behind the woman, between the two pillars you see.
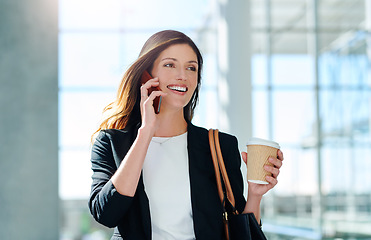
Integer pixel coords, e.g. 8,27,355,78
57,0,222,239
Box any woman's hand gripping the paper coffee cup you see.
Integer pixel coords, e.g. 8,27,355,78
242,150,283,196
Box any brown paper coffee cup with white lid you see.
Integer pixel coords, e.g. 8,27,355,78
246,138,280,184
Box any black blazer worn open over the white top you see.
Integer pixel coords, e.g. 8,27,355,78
89,123,246,240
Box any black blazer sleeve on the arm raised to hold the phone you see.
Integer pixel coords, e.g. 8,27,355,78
89,131,133,228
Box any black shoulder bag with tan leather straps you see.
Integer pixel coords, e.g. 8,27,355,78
209,129,266,240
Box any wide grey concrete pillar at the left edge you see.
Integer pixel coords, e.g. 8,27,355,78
0,0,59,240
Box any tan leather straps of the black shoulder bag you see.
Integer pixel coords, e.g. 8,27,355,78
209,129,238,214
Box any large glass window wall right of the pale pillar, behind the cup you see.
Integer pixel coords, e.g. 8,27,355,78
251,0,371,236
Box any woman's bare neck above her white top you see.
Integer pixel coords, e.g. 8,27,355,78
155,111,188,137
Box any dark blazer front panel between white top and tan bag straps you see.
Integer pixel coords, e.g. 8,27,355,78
188,123,223,240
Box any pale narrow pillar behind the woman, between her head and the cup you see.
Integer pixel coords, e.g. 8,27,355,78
218,0,251,150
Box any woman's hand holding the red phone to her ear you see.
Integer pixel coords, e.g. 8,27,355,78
140,77,166,133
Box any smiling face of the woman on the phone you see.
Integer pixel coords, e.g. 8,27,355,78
152,44,198,109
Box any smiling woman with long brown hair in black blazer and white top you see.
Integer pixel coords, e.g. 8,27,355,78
89,30,283,240
